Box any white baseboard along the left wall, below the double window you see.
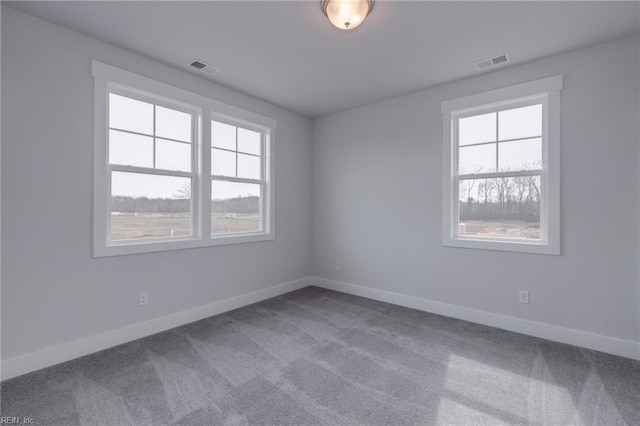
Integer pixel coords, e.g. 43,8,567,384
0,277,311,380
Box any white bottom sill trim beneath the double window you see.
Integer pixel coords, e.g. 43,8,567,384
93,232,275,258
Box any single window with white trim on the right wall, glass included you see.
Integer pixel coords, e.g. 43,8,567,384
442,76,562,254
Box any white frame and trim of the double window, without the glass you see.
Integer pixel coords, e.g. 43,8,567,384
92,61,277,257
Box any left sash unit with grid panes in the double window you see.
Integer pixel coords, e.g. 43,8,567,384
107,86,197,244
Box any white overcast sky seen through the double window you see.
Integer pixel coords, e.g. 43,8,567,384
109,94,260,199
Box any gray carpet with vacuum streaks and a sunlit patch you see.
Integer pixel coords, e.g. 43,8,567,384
2,287,640,426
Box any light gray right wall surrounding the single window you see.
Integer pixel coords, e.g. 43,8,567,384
312,37,640,341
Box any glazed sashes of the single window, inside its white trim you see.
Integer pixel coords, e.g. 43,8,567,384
452,96,546,243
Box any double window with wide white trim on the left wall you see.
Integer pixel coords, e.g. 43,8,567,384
93,61,276,257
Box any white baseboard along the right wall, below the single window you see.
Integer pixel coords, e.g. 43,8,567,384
311,277,640,360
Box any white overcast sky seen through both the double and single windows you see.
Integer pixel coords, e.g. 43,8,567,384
109,94,542,205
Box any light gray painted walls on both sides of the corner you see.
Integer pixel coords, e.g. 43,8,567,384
1,7,640,359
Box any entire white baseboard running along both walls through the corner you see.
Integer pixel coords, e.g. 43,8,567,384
0,277,640,380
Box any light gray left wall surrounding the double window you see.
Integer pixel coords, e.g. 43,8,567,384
2,7,311,359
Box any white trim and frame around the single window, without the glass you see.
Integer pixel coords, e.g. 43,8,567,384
441,75,563,255
